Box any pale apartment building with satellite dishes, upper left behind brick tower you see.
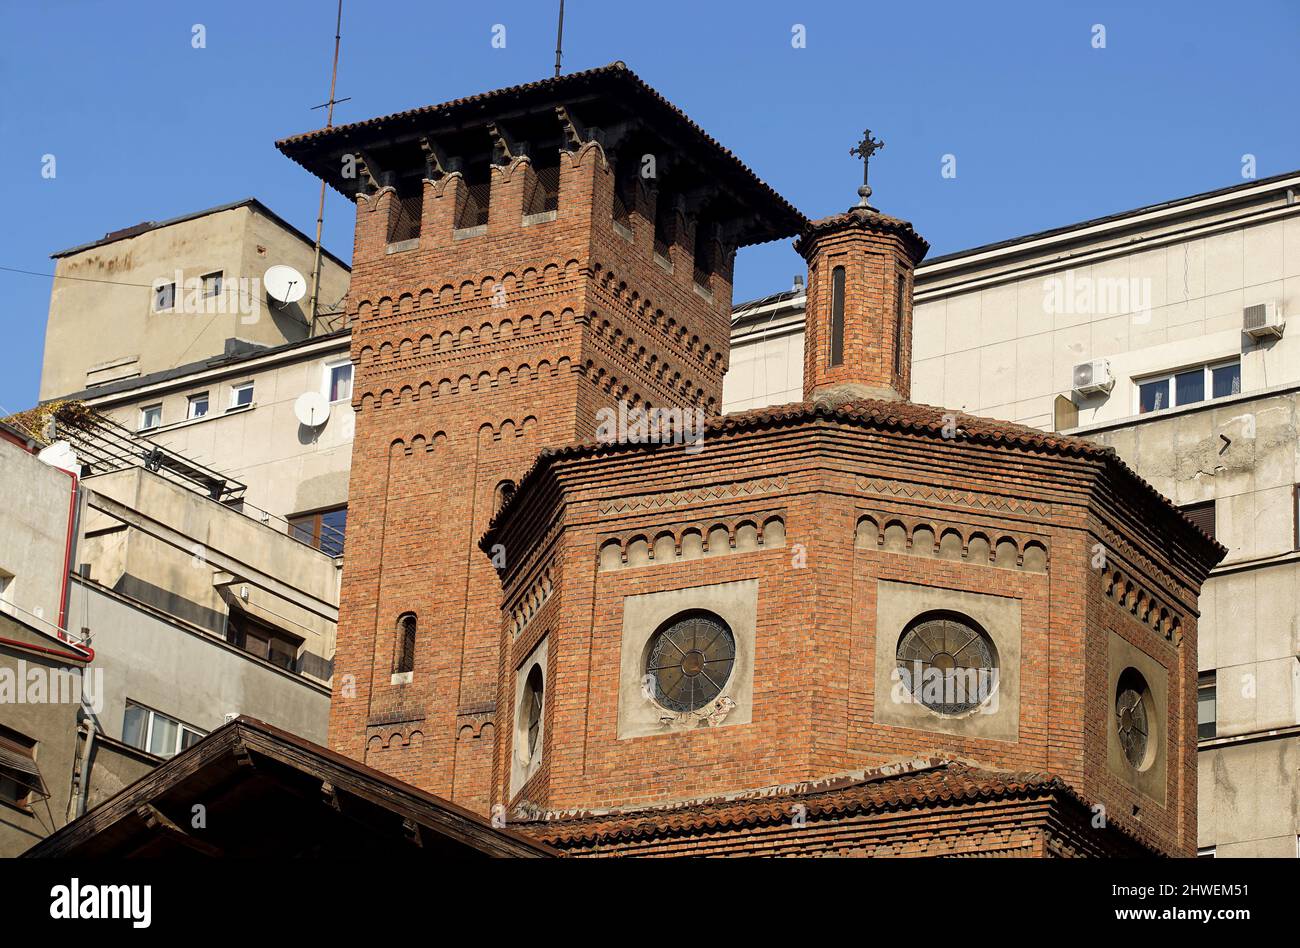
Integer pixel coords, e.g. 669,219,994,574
40,199,352,555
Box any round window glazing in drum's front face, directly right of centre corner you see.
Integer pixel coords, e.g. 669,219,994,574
896,612,997,714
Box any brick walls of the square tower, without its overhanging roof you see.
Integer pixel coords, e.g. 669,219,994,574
330,136,731,811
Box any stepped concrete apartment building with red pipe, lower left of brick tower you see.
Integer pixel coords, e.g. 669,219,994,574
0,404,341,856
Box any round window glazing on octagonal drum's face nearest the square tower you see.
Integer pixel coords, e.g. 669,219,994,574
646,611,736,711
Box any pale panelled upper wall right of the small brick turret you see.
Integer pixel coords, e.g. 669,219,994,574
913,208,1300,428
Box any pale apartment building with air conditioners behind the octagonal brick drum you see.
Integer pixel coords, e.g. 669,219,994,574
724,173,1300,857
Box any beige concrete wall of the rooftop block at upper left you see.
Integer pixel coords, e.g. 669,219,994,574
40,205,347,401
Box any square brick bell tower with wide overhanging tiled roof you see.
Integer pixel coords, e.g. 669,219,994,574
277,62,803,813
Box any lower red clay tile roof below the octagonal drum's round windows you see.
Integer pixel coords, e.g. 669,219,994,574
516,758,1158,850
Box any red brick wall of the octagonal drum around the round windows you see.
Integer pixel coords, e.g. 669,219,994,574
495,424,1197,853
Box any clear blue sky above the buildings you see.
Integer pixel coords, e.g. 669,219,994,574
0,0,1300,411
